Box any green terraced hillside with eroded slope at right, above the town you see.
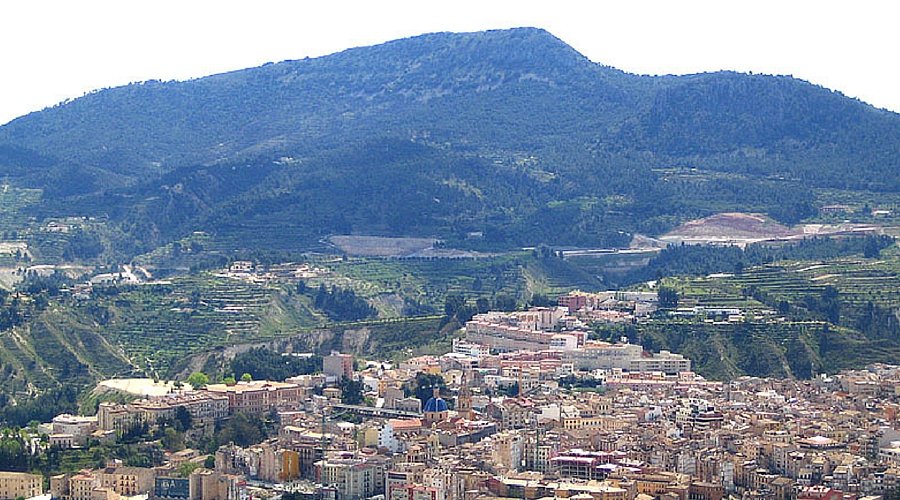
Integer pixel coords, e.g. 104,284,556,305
639,247,900,378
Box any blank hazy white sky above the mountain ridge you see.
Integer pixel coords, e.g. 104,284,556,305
0,0,900,123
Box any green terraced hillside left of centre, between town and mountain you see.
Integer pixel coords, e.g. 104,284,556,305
0,252,596,412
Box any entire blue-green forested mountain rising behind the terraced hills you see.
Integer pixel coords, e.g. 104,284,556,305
0,28,900,256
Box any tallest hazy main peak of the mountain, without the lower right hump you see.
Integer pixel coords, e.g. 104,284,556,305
0,29,633,174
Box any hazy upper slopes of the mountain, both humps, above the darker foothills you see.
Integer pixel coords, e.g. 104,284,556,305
0,27,898,197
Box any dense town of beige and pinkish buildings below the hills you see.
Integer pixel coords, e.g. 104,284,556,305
0,292,900,500
